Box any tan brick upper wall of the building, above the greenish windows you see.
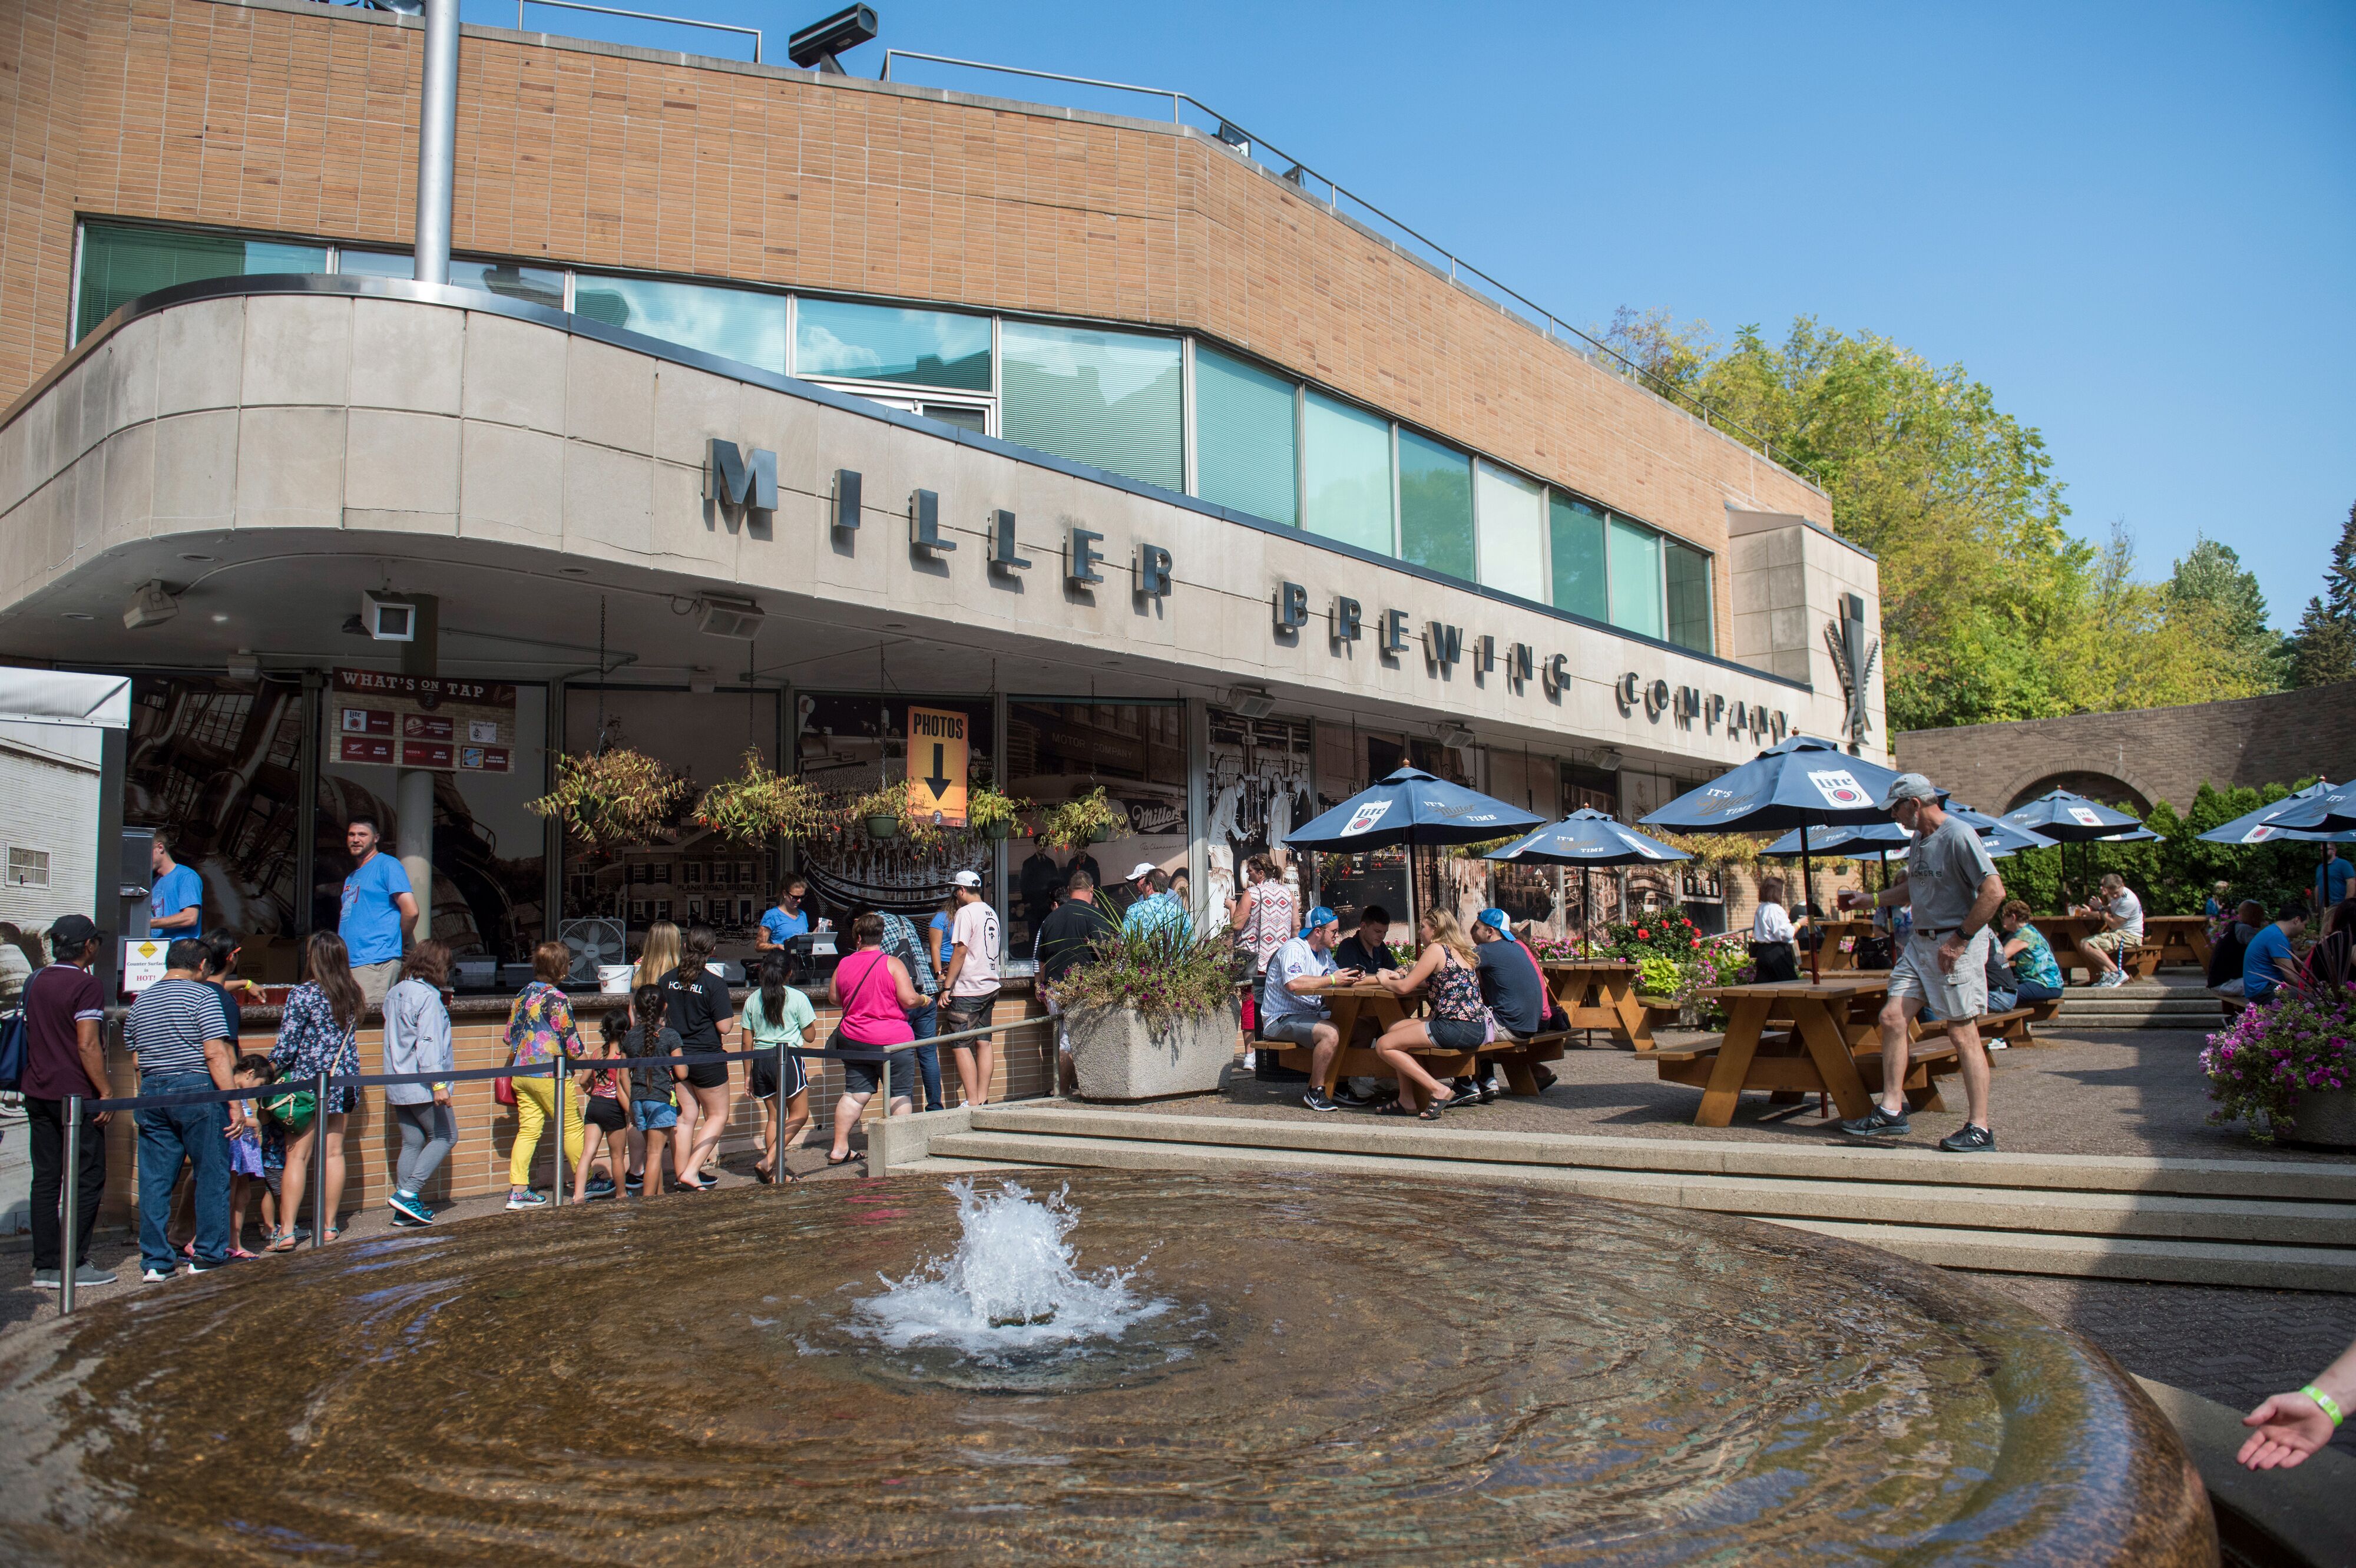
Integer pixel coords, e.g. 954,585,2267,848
0,0,1831,645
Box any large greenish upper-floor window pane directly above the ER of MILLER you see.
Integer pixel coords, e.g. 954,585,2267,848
999,320,1185,489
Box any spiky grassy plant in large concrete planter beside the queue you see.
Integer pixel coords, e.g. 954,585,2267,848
1055,921,1239,1100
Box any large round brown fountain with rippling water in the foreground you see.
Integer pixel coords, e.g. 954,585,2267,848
0,1173,2217,1568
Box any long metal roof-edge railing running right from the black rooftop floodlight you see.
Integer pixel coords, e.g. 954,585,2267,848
886,48,1814,480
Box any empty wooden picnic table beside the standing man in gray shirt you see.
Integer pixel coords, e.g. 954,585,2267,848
1659,977,1890,1128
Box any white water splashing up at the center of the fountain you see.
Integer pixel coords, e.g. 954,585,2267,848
846,1182,1171,1361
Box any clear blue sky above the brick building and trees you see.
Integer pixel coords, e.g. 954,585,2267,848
464,0,2356,626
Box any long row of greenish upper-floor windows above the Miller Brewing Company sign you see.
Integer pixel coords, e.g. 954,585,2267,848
75,224,1713,652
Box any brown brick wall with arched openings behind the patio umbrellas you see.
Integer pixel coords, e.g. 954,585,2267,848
1897,680,2356,812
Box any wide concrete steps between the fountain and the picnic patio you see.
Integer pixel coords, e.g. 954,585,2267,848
895,1104,2356,1292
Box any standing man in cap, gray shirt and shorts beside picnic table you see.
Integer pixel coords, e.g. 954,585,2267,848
1840,772,2005,1154
